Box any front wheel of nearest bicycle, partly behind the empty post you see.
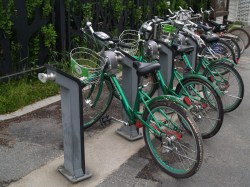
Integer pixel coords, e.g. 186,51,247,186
82,79,113,129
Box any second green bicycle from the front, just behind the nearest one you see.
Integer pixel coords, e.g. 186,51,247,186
137,41,224,139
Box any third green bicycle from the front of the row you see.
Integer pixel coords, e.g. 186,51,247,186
177,22,244,112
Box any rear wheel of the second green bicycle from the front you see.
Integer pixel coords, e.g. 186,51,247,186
175,77,224,139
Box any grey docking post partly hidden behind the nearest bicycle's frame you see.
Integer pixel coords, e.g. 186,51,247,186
116,53,143,141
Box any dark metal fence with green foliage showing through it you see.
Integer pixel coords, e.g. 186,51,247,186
0,0,168,81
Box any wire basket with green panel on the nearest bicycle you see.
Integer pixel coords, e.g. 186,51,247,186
70,47,106,84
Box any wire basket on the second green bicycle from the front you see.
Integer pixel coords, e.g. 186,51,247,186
119,30,140,56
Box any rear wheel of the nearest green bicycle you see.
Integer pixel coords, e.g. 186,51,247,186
142,100,203,178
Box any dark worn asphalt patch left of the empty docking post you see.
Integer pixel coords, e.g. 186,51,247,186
0,102,62,148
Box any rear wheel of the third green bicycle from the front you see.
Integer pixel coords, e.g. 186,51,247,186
203,63,244,112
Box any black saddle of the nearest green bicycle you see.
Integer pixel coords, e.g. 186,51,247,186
133,61,161,76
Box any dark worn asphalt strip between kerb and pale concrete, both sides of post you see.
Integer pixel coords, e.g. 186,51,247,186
0,95,122,150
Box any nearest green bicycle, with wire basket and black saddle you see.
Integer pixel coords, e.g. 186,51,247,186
70,41,203,178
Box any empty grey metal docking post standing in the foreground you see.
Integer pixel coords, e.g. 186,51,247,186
38,65,92,183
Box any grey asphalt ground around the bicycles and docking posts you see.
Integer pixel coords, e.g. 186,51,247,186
0,28,250,187
